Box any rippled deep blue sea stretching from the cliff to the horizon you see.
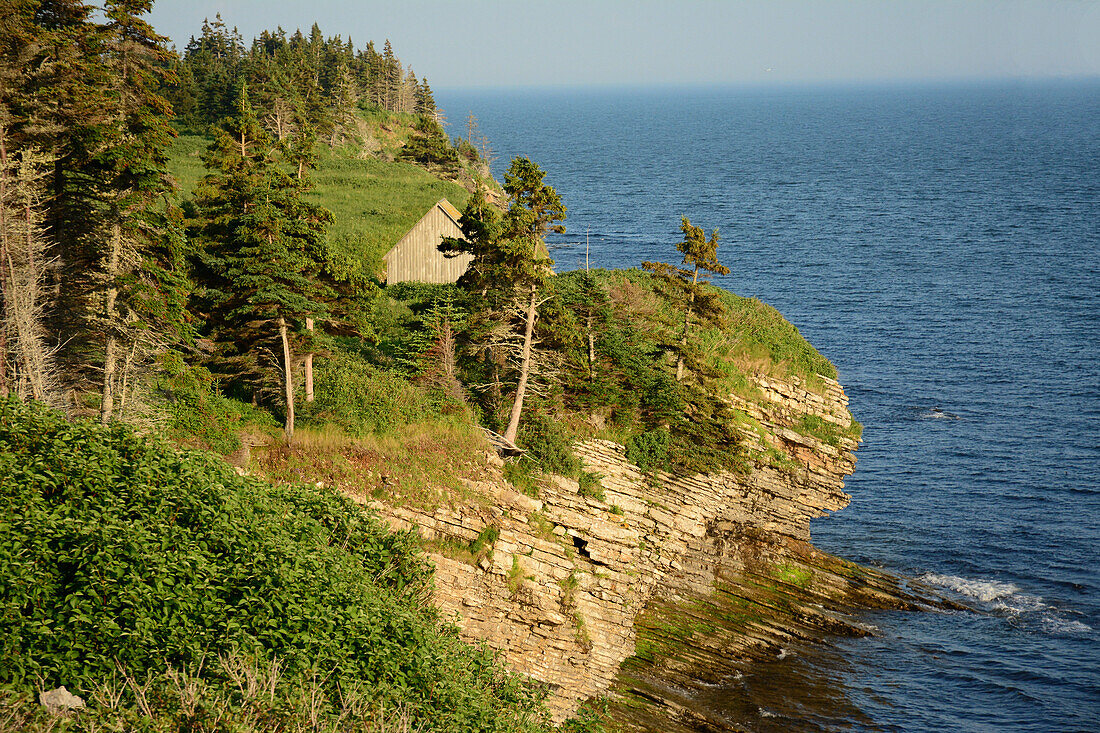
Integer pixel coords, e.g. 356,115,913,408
437,81,1100,732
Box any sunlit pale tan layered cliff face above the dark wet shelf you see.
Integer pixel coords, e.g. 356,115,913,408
365,376,897,729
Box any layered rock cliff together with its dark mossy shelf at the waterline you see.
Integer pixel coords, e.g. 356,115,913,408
376,376,928,730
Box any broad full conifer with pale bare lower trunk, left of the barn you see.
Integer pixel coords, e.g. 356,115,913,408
195,90,331,439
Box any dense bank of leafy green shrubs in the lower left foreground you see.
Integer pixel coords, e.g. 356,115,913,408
0,400,550,731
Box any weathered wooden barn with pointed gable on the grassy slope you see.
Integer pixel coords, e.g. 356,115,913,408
382,198,474,285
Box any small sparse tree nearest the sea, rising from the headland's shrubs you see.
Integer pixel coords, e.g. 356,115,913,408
641,217,729,382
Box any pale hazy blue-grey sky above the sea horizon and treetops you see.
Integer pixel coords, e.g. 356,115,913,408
152,0,1100,89
